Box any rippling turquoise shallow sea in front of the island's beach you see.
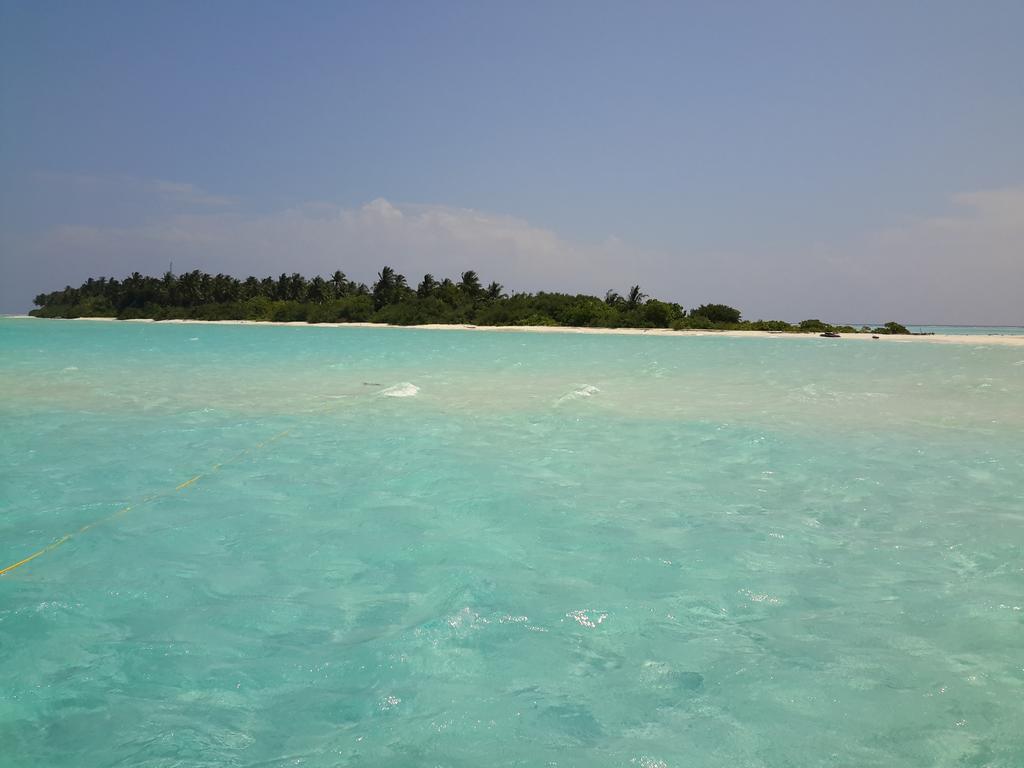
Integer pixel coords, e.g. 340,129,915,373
0,319,1024,768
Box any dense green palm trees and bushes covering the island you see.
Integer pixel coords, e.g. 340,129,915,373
32,266,907,333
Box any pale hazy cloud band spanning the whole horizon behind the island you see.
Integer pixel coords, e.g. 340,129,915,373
4,179,1024,324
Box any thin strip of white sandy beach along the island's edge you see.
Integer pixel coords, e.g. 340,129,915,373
3,314,1024,347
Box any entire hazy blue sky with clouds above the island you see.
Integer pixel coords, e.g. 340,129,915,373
0,0,1024,325
